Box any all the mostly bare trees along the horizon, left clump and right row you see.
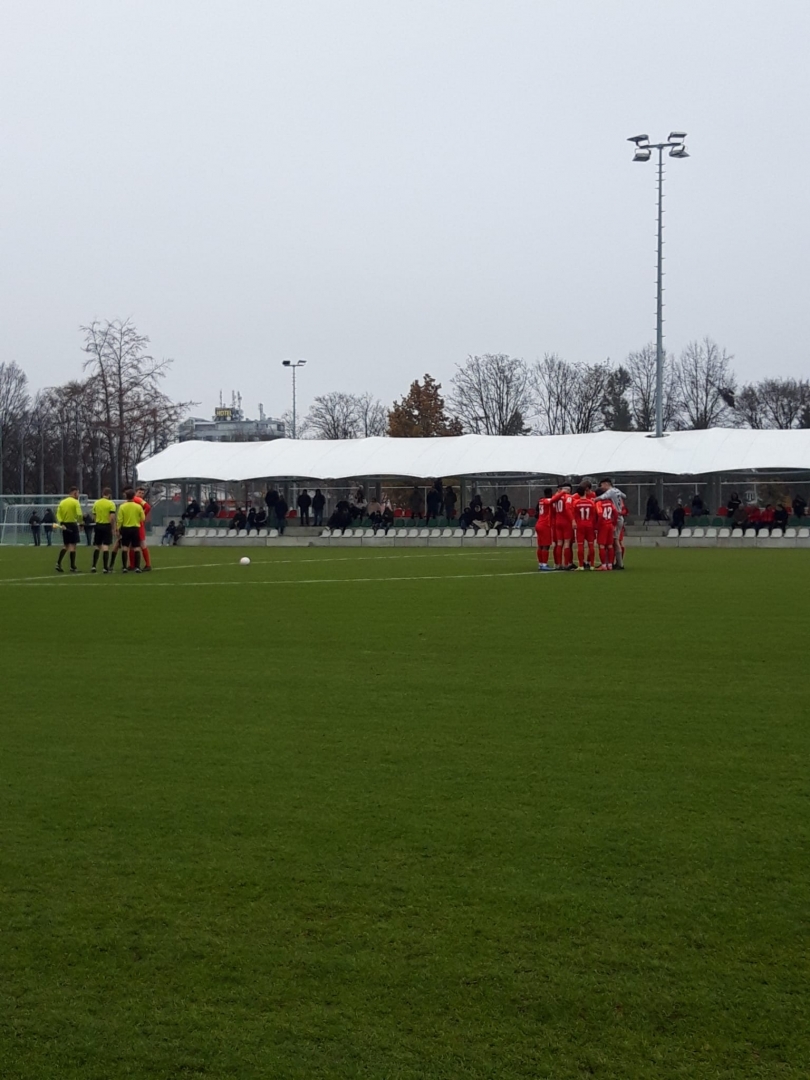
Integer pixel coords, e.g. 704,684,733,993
0,320,810,497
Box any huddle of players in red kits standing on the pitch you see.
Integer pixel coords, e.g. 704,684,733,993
535,481,627,570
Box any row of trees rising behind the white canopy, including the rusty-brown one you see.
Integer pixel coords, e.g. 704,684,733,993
302,337,810,438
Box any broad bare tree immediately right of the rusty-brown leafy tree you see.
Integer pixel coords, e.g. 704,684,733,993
449,353,532,435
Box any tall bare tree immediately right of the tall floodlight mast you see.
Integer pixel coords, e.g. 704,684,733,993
675,337,737,429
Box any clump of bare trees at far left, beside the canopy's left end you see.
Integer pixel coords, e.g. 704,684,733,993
0,320,191,497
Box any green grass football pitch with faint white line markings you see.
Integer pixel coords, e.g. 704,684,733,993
0,548,810,1080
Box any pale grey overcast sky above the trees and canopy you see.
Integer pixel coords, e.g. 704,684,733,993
0,0,810,416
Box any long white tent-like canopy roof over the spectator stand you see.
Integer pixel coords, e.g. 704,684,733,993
138,428,810,482
